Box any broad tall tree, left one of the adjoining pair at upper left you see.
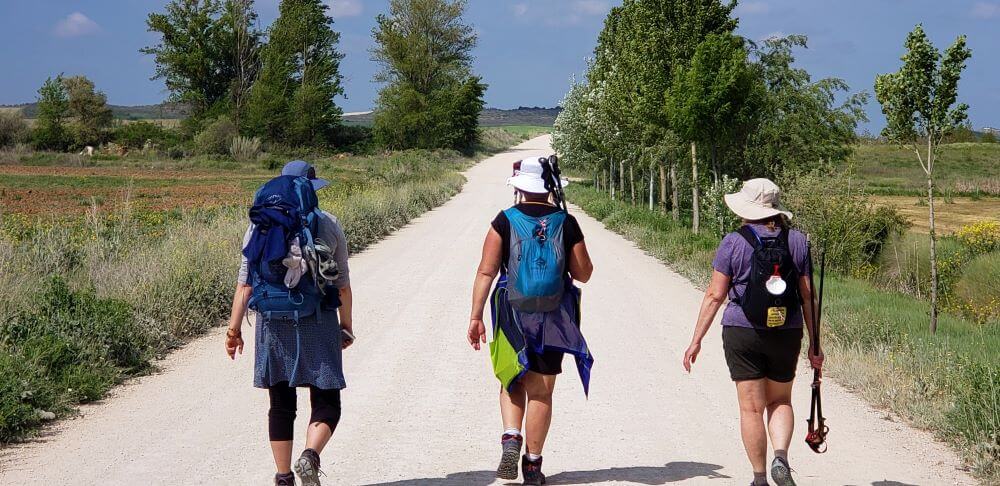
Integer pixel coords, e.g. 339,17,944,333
140,0,236,118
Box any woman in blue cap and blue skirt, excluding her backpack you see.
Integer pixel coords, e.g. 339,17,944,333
226,160,353,486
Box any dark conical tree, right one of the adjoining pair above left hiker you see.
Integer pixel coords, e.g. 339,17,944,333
246,0,344,146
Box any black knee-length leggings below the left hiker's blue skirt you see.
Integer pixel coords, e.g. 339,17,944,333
267,381,340,441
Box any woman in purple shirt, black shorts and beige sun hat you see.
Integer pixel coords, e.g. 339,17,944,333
683,179,823,486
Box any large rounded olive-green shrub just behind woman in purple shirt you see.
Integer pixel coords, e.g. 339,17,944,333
783,171,908,276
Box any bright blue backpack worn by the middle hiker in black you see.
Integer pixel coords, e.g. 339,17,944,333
504,208,566,312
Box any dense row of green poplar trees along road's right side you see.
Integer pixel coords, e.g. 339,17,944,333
553,0,867,232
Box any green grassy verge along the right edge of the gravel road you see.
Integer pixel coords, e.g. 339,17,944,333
567,184,1000,484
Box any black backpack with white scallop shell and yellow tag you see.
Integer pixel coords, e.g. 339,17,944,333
734,226,801,327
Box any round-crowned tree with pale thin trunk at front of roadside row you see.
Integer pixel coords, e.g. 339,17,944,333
666,34,764,233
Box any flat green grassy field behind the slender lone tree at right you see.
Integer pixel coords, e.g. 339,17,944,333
848,143,1000,196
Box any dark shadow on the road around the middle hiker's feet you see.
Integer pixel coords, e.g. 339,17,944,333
367,462,728,486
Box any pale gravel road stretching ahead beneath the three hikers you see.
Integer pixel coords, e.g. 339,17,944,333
0,137,972,486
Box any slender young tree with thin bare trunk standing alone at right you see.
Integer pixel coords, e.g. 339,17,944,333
875,24,972,333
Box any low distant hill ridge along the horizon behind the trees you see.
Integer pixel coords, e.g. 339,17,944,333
0,103,562,127
